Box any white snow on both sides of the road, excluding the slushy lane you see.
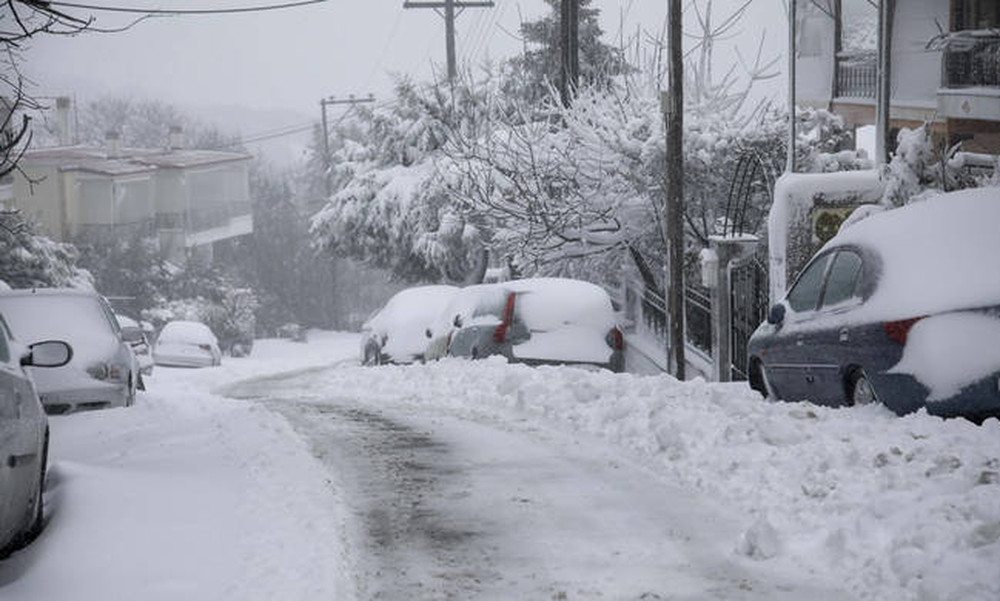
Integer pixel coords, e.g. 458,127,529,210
0,333,1000,601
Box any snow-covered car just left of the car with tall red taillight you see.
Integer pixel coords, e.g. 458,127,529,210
361,286,458,365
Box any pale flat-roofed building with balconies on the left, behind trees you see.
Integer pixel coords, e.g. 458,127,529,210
8,127,253,262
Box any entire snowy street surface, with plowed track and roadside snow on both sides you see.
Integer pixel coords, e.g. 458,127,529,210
0,332,1000,601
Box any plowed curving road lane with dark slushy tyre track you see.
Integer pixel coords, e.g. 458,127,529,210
238,373,849,600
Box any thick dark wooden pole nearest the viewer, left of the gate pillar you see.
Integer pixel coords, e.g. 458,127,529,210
663,0,685,380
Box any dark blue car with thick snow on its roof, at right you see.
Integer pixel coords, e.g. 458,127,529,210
747,187,1000,419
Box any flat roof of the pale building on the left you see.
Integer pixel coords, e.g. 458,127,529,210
22,146,251,176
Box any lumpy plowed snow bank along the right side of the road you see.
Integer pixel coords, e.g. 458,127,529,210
292,358,1000,601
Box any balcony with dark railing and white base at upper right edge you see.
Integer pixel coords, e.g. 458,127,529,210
938,30,1000,121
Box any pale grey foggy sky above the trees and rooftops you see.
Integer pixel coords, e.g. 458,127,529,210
25,0,787,148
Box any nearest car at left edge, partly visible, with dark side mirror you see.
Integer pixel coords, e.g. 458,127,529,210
0,317,73,558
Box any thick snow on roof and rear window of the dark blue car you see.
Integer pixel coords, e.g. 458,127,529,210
824,187,1000,319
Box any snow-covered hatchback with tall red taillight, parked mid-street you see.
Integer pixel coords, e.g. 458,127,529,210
428,278,625,372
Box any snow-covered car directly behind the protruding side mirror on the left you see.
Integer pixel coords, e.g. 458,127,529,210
0,288,139,414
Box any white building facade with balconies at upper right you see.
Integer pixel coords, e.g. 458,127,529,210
796,0,1000,155
